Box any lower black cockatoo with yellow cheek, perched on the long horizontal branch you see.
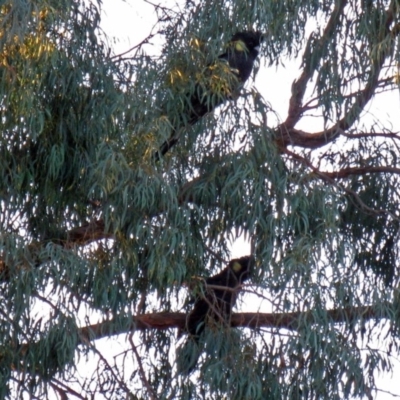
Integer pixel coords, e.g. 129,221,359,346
186,256,254,341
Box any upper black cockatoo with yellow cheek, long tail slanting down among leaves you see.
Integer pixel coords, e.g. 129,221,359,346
155,31,262,160
